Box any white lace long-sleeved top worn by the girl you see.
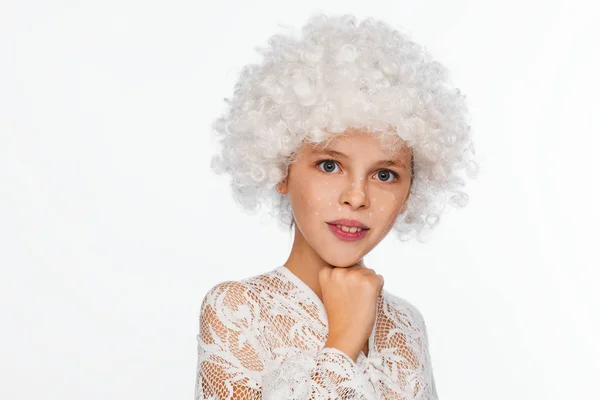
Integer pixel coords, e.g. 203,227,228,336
195,265,437,400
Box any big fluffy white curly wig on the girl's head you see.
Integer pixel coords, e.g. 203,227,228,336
211,14,478,242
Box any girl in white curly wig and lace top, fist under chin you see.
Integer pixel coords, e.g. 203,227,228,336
195,14,477,400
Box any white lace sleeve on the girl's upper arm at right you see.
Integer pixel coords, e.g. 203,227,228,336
367,300,438,400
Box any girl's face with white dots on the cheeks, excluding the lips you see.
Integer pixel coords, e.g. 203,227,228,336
278,130,412,267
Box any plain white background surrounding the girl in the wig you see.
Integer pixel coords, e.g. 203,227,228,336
0,0,600,400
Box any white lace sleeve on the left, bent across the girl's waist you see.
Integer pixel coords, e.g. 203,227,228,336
195,281,376,400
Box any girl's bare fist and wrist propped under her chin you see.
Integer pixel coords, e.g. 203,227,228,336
319,262,384,361
